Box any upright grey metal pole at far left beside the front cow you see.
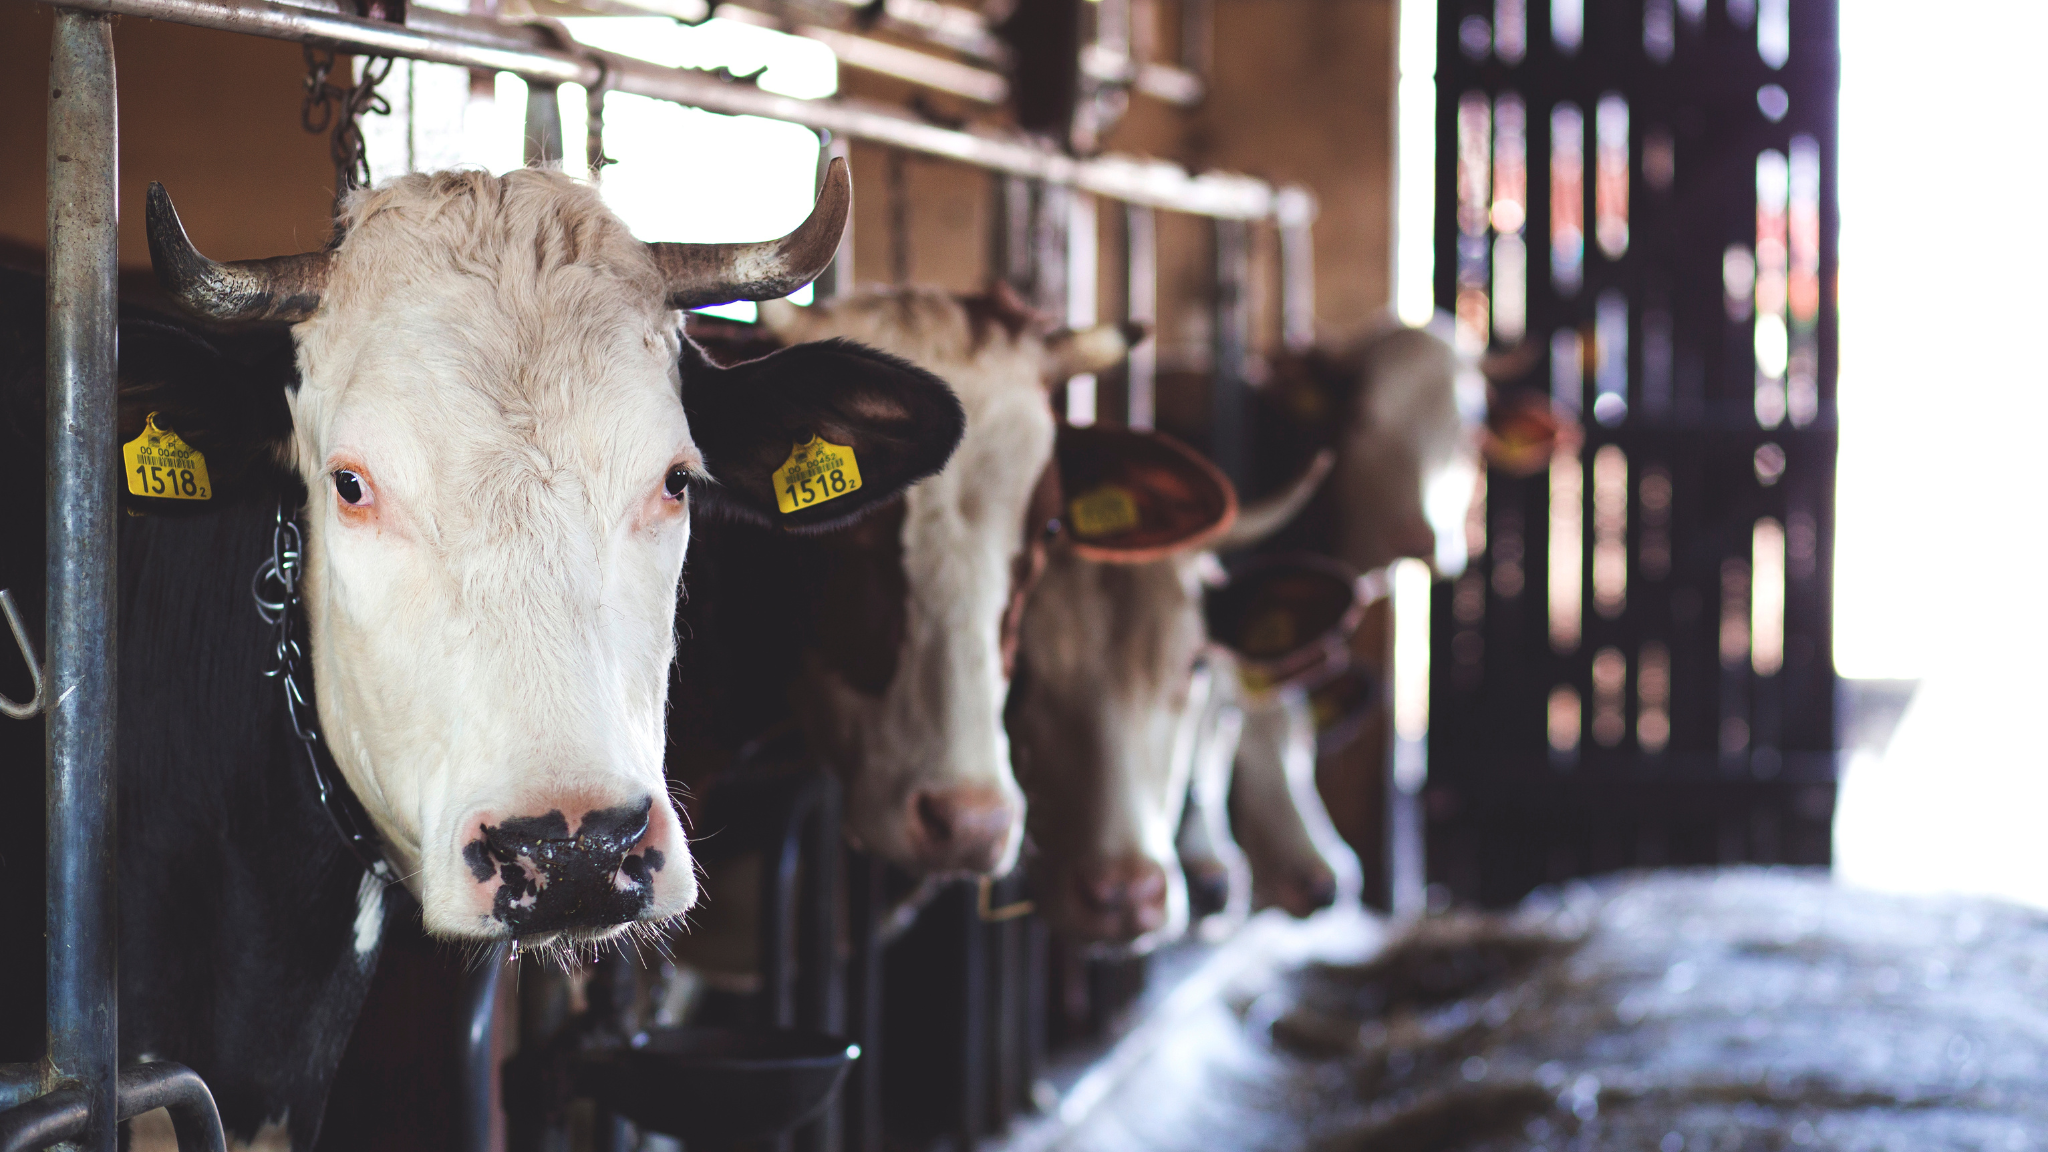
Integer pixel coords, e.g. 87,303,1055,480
43,8,119,1152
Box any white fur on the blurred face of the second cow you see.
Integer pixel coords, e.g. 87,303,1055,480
762,289,1053,873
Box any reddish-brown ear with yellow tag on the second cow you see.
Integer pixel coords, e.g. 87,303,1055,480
1055,426,1237,564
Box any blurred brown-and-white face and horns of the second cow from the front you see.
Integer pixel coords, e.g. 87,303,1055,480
762,287,1130,873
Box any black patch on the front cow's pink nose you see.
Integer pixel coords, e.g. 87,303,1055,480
463,797,668,937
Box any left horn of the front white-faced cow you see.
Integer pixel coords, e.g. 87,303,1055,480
150,182,334,324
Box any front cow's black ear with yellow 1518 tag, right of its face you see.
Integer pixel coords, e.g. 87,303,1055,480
682,332,967,531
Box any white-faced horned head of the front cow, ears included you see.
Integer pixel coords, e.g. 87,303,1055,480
137,166,958,945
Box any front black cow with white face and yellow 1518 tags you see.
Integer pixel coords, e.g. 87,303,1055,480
0,164,963,1148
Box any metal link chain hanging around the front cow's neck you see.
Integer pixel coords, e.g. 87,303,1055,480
250,502,397,883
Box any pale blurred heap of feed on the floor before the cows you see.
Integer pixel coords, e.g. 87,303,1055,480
1051,869,2048,1152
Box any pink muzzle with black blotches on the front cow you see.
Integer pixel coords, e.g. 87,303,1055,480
463,795,696,939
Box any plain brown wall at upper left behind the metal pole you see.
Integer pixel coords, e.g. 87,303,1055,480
0,4,346,271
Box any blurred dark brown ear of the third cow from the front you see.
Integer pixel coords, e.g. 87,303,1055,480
1202,553,1368,687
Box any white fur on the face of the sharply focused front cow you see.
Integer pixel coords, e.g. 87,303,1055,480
291,170,700,937
